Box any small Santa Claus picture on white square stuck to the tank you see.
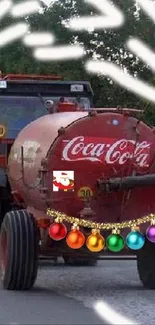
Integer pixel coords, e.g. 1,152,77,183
53,172,74,192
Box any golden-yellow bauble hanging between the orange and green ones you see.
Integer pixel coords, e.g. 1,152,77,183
86,229,105,252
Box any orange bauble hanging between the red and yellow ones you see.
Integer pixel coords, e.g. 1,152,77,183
66,224,85,249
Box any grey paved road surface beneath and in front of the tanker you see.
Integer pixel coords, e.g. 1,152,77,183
0,261,155,325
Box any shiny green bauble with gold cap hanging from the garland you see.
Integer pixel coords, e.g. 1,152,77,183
106,229,125,252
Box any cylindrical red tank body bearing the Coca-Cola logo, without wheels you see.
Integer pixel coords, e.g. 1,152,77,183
8,112,155,222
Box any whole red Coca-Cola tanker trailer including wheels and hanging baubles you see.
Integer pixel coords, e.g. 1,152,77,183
0,104,155,290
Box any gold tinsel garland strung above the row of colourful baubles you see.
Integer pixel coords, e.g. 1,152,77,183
47,209,155,230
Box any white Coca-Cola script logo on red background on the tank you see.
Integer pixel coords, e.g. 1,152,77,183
62,136,151,167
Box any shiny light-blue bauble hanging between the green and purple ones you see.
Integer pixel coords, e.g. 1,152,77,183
126,231,145,250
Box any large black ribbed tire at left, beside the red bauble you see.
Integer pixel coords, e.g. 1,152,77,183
0,210,38,290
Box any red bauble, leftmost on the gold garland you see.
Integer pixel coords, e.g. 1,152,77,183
48,222,67,240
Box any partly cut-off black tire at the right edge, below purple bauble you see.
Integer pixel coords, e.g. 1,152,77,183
137,235,155,289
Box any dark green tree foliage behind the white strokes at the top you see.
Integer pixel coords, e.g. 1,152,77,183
0,0,155,124
